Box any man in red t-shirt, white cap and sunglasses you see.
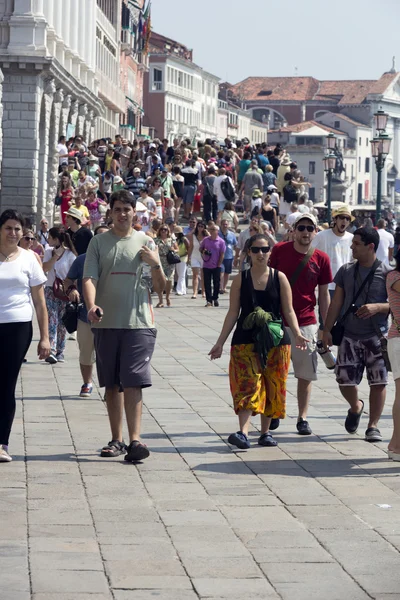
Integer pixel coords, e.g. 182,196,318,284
269,213,333,435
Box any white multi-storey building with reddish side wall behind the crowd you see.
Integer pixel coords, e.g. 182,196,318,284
143,33,219,141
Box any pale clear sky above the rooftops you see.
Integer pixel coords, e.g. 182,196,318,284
152,0,400,83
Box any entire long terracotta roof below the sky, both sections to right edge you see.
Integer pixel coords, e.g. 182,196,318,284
230,72,399,105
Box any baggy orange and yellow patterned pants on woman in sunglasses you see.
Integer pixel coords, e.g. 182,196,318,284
229,344,290,419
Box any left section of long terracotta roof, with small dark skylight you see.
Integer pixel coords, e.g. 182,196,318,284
231,77,319,102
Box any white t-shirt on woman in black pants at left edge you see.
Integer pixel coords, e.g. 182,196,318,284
0,248,46,323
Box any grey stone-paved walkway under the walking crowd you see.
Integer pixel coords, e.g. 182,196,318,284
0,296,400,600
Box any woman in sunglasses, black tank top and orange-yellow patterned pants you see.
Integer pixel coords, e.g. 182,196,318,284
209,234,307,449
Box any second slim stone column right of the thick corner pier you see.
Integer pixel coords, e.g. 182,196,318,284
45,89,63,224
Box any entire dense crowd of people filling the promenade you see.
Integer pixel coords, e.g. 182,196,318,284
0,136,400,462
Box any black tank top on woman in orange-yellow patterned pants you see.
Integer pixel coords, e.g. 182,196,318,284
231,268,290,346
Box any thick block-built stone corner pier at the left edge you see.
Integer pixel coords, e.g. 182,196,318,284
0,68,42,221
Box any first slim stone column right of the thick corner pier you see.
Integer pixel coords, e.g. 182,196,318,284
36,78,57,223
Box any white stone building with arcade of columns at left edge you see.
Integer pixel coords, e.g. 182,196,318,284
0,0,104,222
